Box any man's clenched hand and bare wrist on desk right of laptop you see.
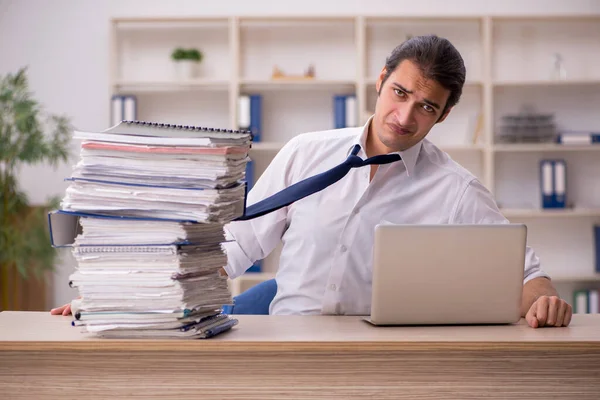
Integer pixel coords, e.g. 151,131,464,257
521,278,573,328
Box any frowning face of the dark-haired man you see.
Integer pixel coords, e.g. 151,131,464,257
370,60,450,153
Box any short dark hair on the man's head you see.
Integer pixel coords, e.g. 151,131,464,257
379,35,467,115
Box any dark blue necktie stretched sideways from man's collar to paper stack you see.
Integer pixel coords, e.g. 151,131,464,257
236,144,401,221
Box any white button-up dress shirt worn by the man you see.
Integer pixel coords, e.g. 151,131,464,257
225,120,548,315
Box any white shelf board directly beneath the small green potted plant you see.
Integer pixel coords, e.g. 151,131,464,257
115,79,229,92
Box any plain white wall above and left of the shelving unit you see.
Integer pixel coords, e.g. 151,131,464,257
0,0,600,305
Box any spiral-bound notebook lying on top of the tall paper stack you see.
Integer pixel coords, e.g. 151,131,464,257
73,120,252,147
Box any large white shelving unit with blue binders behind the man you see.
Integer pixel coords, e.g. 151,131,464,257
110,15,600,293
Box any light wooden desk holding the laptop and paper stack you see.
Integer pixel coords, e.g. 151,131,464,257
0,312,600,400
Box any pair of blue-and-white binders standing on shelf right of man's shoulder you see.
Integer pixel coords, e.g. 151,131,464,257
540,160,567,208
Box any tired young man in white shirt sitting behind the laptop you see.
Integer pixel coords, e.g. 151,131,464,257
53,36,572,328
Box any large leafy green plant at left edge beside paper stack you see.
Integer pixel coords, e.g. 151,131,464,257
0,68,71,310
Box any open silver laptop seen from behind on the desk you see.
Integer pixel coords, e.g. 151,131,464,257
365,224,527,325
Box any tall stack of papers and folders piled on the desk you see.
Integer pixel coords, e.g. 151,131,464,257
54,121,251,338
